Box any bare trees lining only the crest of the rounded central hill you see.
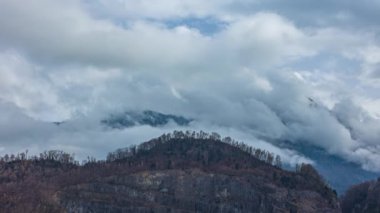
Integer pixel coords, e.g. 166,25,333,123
106,130,282,168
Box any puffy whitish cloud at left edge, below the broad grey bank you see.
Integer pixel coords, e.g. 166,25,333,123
0,51,70,120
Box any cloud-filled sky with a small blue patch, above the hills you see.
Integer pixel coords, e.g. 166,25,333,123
0,0,380,171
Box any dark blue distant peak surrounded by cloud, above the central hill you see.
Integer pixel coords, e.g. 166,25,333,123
101,110,192,129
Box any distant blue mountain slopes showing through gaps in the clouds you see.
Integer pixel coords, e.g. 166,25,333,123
54,108,380,195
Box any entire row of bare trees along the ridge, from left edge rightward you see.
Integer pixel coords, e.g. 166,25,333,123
0,131,282,168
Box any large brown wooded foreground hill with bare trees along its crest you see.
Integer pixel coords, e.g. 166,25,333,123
0,131,340,212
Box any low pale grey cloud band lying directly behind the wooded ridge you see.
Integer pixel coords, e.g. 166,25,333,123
0,100,312,166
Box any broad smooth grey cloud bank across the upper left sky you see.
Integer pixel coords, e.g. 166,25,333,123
0,0,208,68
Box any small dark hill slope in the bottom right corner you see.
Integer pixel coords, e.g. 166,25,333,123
341,178,380,213
